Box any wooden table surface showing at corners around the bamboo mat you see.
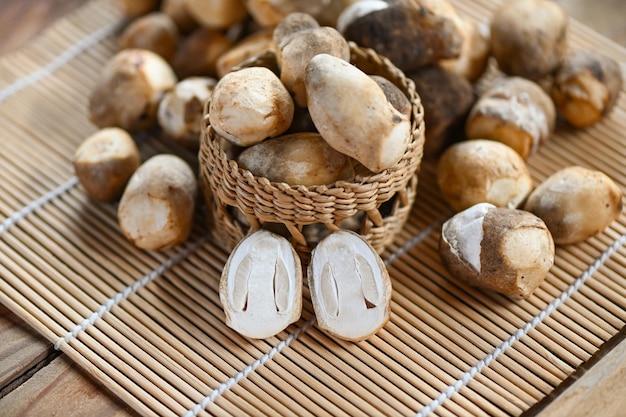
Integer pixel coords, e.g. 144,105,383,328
0,0,626,417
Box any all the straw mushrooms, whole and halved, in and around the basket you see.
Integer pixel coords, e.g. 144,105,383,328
74,0,622,341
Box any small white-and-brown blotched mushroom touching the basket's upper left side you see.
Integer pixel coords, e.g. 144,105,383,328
157,77,217,149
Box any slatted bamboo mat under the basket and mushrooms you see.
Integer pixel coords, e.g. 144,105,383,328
0,0,626,416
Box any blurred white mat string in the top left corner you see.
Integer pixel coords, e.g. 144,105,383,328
0,21,124,103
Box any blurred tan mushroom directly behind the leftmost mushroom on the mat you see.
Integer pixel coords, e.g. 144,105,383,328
89,49,177,132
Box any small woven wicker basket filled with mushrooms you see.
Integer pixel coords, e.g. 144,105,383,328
199,43,424,256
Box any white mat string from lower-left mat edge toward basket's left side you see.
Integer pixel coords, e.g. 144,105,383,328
54,236,207,350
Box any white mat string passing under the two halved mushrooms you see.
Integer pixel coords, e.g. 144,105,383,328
183,215,447,417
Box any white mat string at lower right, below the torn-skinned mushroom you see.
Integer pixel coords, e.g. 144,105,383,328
415,229,626,417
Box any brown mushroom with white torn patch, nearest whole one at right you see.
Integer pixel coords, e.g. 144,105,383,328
439,203,555,299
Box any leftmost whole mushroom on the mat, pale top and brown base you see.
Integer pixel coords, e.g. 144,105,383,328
73,127,141,203
